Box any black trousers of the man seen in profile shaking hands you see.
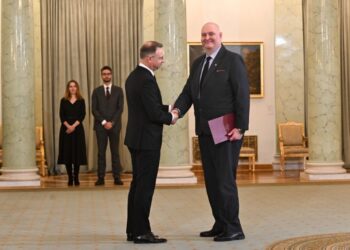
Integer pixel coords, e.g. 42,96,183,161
126,148,160,236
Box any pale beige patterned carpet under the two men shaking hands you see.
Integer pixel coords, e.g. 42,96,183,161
0,184,350,250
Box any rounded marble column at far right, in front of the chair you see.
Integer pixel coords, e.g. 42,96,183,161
304,0,349,179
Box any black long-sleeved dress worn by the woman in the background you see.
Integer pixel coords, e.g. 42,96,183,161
57,98,87,165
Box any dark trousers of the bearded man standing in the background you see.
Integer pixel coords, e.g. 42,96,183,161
96,128,122,178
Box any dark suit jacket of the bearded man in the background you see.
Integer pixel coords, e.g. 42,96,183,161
91,85,124,130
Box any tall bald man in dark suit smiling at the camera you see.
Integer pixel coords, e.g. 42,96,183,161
174,23,249,241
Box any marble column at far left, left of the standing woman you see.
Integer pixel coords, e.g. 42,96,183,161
0,0,40,186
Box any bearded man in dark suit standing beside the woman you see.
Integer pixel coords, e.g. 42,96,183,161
91,66,124,186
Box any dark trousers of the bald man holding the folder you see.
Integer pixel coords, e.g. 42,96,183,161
199,135,242,233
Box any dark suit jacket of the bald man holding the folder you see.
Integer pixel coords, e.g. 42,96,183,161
174,46,249,135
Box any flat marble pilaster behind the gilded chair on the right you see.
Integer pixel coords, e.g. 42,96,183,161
272,0,305,170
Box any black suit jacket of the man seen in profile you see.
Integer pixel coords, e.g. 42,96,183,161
124,66,172,150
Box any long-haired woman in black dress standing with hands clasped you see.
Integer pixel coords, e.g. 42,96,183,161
57,80,87,186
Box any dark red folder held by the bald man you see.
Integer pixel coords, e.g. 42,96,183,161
208,113,235,144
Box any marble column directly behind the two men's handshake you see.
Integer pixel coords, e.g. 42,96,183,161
154,0,197,183
